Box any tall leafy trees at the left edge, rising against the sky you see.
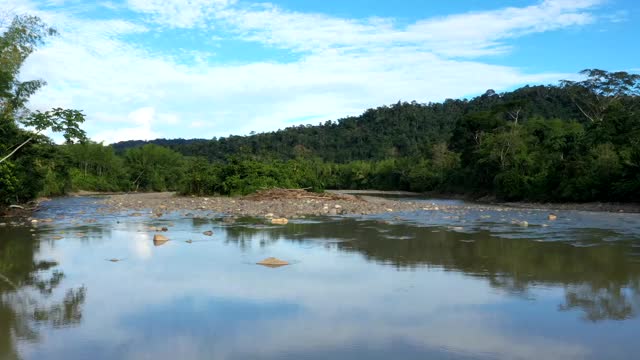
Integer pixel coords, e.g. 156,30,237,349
0,16,86,206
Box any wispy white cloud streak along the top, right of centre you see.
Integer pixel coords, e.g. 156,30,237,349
217,0,602,56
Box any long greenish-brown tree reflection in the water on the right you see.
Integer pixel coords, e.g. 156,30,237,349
227,220,640,322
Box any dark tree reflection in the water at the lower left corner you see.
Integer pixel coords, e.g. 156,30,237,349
0,228,86,359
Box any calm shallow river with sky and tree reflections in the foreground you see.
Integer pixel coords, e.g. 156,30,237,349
0,198,640,360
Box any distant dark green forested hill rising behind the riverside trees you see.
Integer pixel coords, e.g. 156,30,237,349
113,86,584,163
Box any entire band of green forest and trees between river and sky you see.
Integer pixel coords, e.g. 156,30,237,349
0,16,640,211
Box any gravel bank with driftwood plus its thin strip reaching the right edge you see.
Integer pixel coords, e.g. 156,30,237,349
94,190,640,218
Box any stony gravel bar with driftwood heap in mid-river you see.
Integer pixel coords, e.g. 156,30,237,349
104,190,438,218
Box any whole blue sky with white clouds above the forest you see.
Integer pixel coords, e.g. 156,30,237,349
0,0,640,143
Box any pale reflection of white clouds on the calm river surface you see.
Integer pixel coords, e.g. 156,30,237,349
27,229,595,360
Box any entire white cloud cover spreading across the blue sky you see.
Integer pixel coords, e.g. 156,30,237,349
3,0,616,141
